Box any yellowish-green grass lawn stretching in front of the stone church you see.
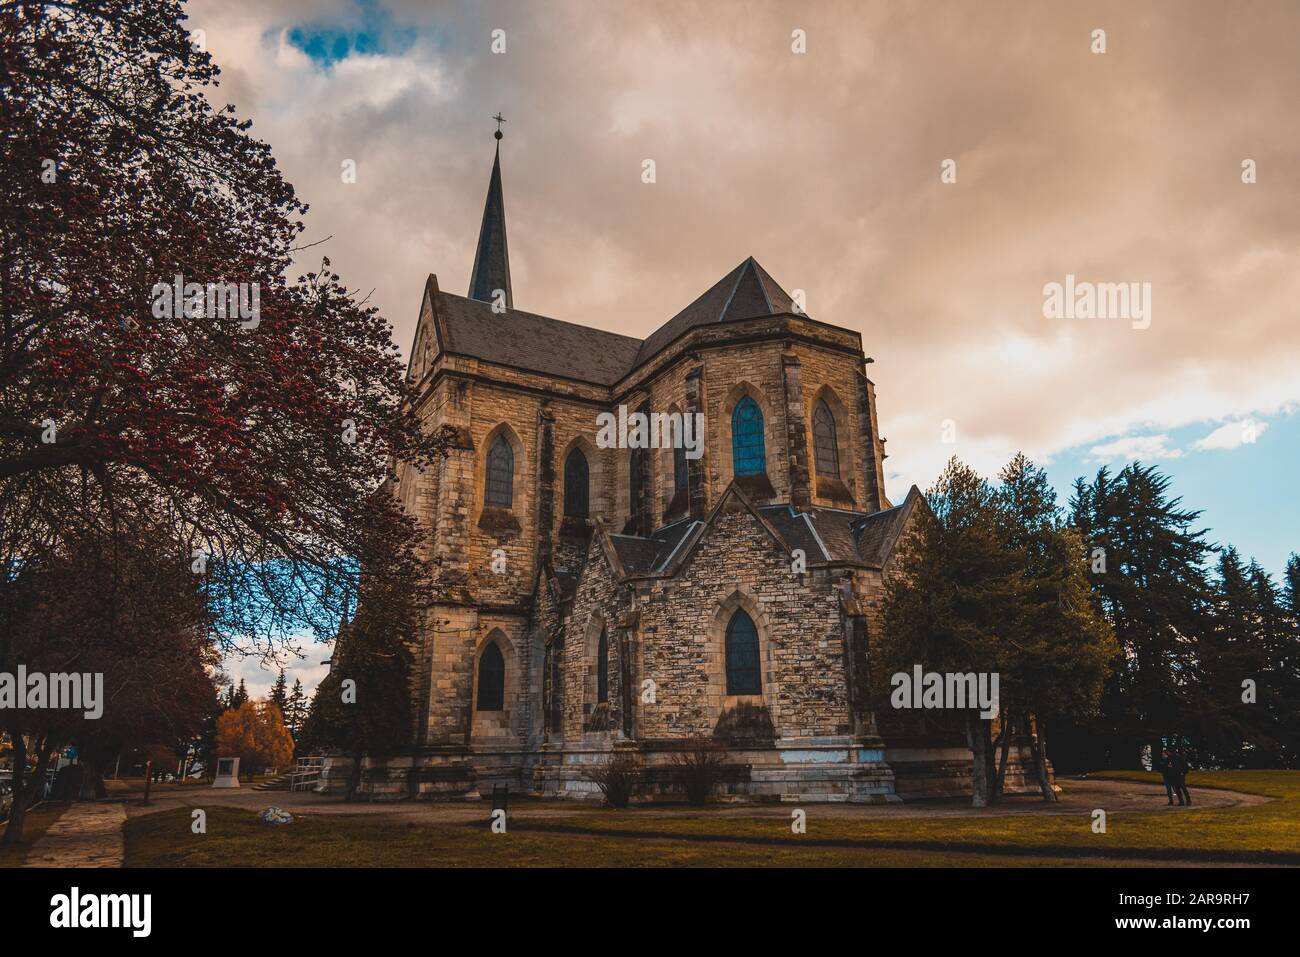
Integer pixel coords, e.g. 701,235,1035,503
126,771,1300,867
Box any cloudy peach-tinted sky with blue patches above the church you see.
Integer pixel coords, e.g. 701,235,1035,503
190,0,1300,685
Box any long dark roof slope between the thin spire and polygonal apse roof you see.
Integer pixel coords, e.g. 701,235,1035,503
436,291,641,385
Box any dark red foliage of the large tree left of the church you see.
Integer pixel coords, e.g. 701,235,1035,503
0,0,445,648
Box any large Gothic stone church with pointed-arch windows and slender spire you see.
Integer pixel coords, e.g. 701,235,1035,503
340,131,1027,802
